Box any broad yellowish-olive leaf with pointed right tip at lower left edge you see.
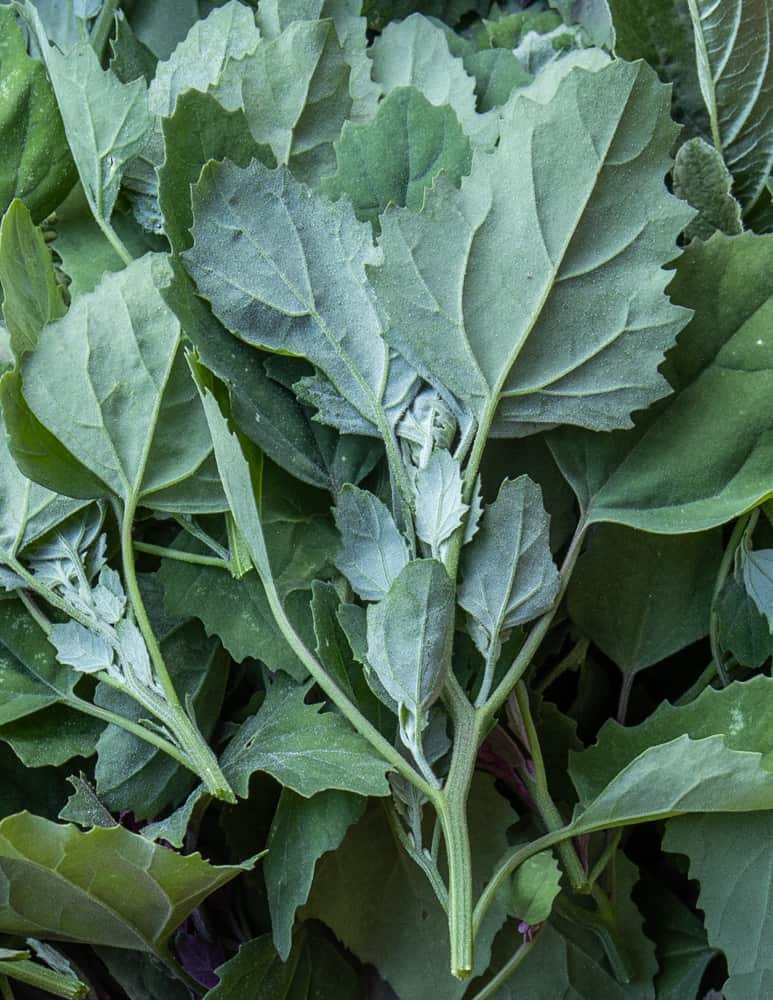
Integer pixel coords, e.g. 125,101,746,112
0,813,251,954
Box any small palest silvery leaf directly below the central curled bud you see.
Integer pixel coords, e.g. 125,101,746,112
414,450,469,559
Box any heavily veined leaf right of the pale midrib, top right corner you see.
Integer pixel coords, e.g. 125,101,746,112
688,0,773,210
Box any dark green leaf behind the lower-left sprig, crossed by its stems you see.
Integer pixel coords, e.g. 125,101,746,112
94,622,228,819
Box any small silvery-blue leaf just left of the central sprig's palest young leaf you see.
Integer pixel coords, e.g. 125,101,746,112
335,486,409,601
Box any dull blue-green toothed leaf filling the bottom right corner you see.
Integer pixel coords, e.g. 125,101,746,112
663,812,773,1000
